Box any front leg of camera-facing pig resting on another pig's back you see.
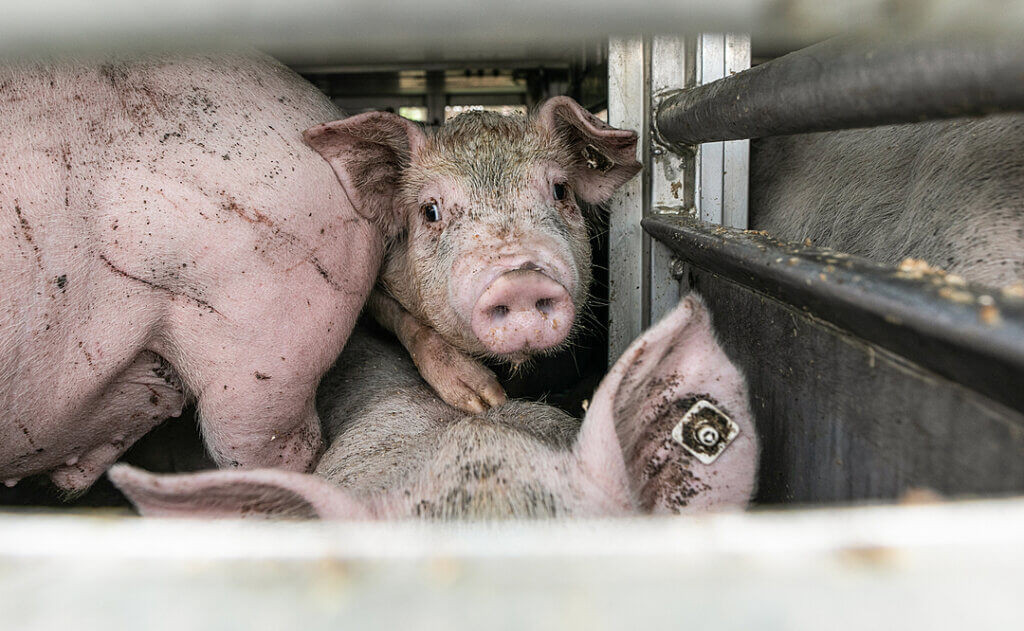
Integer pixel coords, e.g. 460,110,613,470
369,289,505,414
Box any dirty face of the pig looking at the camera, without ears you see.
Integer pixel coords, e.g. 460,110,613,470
397,113,590,362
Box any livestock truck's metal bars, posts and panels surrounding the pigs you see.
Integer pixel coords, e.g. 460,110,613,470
0,0,1024,629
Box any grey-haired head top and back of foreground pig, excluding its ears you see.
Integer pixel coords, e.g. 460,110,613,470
316,326,581,518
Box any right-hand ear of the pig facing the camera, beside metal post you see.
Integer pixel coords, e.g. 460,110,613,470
537,96,641,204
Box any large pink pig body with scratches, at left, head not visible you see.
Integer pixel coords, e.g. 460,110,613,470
0,56,383,491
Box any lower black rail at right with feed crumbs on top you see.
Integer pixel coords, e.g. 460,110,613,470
643,216,1024,412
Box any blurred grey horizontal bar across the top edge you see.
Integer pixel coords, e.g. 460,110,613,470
6,0,1024,68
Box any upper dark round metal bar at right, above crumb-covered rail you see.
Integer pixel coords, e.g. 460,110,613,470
656,36,1024,145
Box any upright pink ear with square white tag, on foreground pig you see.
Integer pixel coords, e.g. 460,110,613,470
577,294,758,513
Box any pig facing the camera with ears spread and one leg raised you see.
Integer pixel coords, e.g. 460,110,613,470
306,96,640,412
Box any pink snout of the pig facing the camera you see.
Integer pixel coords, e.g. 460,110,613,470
470,269,575,354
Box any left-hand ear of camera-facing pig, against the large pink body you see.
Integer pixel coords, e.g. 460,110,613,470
302,112,426,237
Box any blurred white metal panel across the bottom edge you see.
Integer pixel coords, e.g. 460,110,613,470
0,500,1024,631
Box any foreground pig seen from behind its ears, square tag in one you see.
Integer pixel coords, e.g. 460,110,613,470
110,297,758,519
